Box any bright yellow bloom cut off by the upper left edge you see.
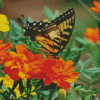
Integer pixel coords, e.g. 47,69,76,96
0,14,10,32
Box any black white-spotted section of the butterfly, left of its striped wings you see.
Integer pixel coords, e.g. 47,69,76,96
23,21,49,41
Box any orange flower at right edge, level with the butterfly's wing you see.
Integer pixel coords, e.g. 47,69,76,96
84,27,100,44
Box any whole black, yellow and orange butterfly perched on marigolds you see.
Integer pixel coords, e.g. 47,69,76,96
17,8,75,58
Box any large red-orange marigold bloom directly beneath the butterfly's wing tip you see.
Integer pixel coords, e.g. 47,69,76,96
36,57,79,90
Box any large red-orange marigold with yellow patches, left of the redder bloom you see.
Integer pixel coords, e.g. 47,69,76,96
0,44,43,81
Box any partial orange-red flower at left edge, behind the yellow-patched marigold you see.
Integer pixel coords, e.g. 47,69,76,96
0,39,13,65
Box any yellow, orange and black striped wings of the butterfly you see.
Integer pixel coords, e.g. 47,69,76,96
35,8,75,57
